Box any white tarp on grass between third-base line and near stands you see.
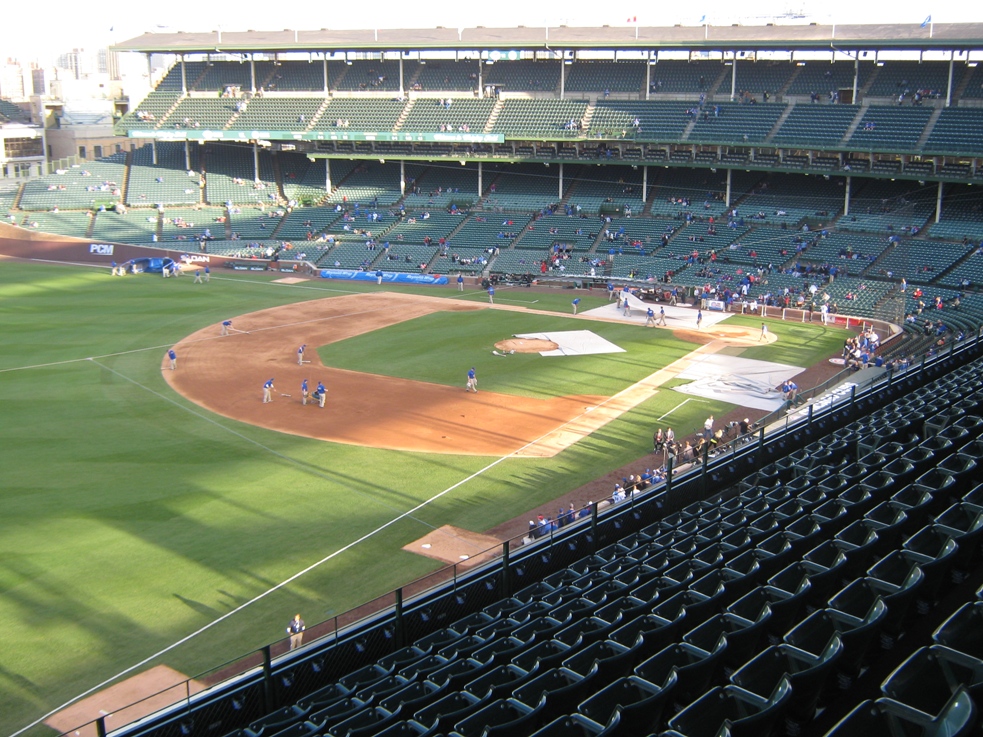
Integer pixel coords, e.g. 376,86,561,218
674,353,802,412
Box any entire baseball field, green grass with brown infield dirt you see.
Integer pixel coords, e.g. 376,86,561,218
0,261,844,734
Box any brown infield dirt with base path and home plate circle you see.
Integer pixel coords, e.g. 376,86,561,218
163,293,774,457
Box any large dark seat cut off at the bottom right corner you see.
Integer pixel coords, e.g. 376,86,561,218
826,690,976,737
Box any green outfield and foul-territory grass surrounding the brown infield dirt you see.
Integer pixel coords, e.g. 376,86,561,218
0,262,836,733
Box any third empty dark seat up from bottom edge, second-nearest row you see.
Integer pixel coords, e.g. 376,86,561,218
783,599,887,676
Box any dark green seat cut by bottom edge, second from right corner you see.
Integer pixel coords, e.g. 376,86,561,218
669,679,792,737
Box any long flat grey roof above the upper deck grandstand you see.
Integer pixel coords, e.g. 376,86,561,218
113,23,983,54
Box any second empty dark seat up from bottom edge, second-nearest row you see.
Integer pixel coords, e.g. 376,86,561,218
730,636,843,722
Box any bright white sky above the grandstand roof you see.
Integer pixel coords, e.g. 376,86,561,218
0,0,983,60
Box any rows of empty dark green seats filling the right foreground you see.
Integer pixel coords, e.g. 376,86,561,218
146,344,983,737
